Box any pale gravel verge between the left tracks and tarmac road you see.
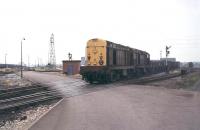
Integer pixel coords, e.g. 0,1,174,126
0,100,59,130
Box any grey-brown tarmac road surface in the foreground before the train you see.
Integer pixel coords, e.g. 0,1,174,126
23,73,200,130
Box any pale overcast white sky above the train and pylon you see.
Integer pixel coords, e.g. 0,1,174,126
0,0,200,64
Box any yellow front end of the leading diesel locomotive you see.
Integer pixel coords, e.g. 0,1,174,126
86,39,107,66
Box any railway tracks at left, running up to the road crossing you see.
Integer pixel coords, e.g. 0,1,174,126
0,84,62,113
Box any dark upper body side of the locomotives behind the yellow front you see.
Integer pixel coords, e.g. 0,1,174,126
107,41,150,67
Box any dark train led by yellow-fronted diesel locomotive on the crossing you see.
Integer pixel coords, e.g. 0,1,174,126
80,38,180,83
